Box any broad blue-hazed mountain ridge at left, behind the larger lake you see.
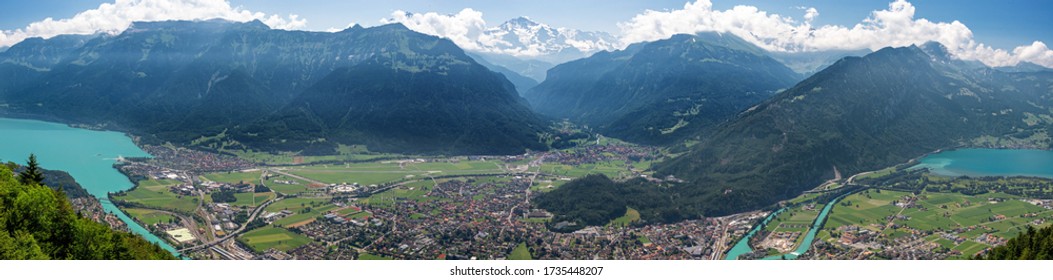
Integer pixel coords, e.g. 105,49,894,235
0,20,545,154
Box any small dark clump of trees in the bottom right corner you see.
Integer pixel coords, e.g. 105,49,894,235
977,226,1053,260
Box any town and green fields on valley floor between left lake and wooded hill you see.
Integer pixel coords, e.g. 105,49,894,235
102,141,762,259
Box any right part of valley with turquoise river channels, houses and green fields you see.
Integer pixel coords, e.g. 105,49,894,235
728,149,1053,260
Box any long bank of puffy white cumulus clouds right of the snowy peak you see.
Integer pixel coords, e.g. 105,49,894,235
618,0,1053,67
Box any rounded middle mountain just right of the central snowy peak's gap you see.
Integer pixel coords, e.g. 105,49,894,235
525,33,800,144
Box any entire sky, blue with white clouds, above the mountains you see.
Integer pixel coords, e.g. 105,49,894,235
0,0,1053,66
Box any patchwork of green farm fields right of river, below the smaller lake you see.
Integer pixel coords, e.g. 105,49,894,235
819,189,1053,256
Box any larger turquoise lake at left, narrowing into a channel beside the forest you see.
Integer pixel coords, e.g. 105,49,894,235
0,118,176,254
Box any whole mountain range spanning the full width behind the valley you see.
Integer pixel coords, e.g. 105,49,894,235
0,19,1053,221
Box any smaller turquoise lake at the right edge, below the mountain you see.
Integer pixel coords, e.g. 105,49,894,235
914,148,1053,178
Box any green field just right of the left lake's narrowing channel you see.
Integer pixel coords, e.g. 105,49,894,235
114,180,198,213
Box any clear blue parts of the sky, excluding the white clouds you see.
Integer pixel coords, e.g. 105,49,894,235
0,0,1053,48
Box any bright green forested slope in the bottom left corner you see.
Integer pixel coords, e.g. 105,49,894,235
0,164,175,260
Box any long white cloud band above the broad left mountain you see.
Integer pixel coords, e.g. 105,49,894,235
0,0,307,46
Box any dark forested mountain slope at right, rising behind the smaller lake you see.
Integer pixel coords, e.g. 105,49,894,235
655,43,1053,216
